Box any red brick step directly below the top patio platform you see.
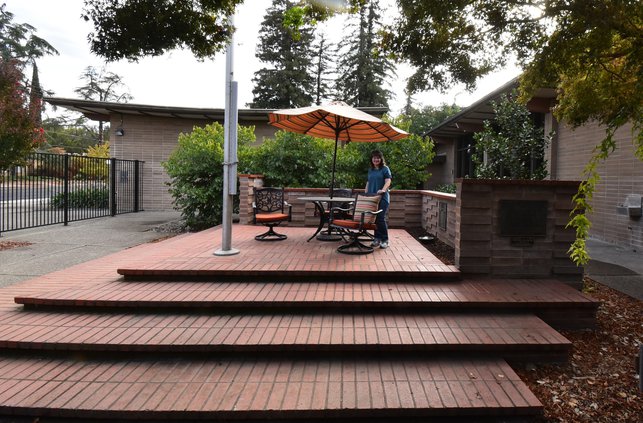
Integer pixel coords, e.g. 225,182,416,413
15,279,598,309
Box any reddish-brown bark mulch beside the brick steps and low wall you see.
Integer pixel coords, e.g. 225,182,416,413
408,229,643,423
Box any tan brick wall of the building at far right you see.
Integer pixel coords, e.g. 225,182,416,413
556,124,643,251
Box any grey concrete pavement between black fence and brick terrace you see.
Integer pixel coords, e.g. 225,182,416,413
0,211,180,286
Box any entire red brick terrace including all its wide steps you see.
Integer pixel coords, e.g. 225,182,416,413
0,226,597,421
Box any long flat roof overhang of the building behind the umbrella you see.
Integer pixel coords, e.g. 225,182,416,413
44,97,388,122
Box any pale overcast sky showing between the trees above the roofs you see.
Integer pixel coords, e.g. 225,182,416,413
6,0,518,114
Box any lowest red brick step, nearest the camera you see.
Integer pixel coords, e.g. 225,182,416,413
0,357,542,420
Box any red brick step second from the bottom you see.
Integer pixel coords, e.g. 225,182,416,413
0,311,571,355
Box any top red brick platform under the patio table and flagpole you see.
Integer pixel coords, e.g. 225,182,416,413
118,226,460,281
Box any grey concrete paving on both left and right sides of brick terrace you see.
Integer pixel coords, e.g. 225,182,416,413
0,211,643,300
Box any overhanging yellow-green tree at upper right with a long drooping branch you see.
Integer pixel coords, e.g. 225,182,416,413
384,0,643,264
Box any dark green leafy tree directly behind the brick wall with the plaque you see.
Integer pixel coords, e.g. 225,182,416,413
472,92,551,180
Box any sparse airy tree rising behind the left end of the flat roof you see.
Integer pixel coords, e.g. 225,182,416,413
74,66,133,144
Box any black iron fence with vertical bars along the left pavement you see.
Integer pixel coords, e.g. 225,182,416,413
0,153,143,233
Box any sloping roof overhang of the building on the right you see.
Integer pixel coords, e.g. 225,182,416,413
426,78,556,139
